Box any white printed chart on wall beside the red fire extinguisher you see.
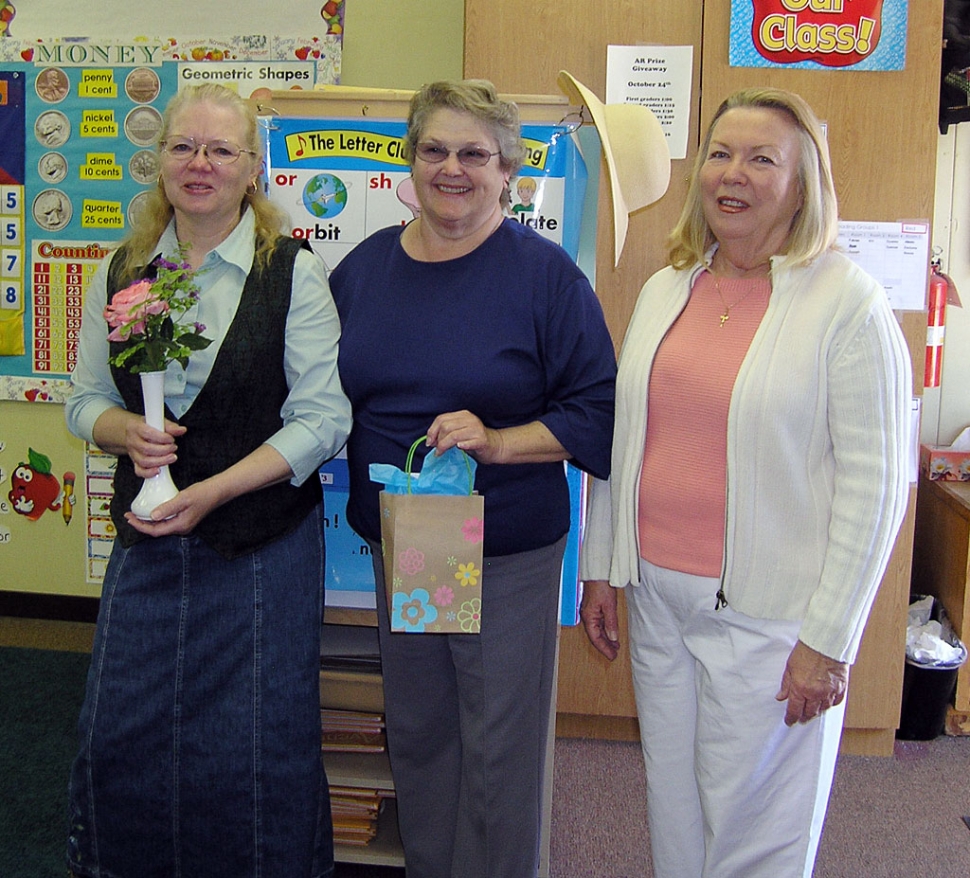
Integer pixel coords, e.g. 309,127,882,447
838,220,930,311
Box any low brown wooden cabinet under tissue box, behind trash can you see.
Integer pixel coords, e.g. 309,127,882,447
913,476,970,734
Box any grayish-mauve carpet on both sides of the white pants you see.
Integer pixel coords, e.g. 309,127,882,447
550,737,970,878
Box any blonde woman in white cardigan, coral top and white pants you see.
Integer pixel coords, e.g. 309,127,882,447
582,88,911,878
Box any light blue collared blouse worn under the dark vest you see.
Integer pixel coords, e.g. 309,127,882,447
65,210,351,485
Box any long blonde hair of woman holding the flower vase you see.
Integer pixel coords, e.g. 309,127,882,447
114,83,287,283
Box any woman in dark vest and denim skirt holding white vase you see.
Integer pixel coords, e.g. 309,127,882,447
61,85,350,878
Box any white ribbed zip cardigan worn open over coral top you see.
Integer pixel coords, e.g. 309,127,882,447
581,251,912,662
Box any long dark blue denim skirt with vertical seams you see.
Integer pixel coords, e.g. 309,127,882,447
68,507,333,878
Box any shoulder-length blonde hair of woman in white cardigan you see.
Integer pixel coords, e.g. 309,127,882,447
667,87,839,268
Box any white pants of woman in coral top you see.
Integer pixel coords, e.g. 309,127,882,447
626,560,845,878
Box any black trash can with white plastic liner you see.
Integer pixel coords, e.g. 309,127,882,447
896,595,967,741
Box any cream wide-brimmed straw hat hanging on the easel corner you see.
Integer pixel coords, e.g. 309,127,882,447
557,70,670,265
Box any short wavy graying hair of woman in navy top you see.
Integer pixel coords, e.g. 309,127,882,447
402,79,525,176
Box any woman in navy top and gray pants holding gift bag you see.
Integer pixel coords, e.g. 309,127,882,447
330,80,615,878
